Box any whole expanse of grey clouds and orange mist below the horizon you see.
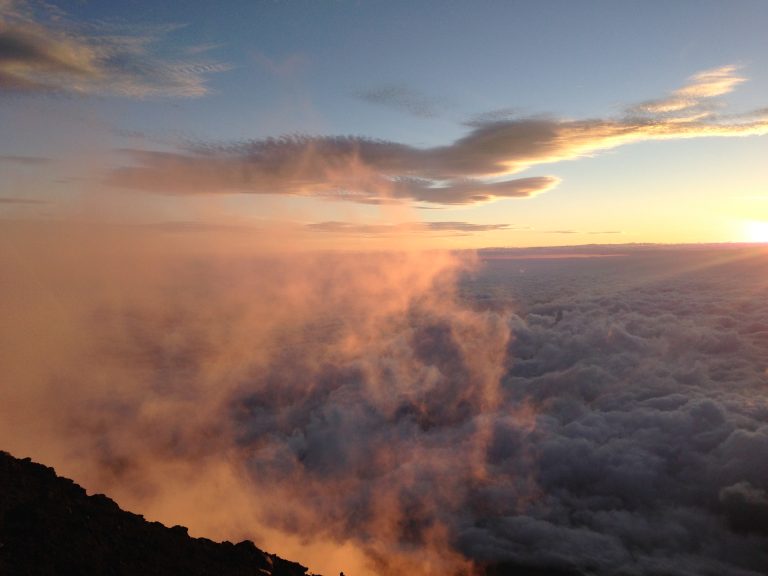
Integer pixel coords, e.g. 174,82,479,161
0,233,768,576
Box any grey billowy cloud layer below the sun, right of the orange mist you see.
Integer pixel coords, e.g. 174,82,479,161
452,248,768,575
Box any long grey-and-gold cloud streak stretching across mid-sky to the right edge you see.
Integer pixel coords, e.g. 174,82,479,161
109,67,768,205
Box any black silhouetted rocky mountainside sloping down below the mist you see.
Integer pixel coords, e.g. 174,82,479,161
0,451,316,576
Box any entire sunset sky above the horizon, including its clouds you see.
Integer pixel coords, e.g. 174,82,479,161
0,0,768,247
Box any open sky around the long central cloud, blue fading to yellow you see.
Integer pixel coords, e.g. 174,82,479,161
0,0,768,245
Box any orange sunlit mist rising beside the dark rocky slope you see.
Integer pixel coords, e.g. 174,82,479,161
0,225,516,574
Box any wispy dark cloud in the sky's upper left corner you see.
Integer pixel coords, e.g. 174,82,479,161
0,2,228,98
